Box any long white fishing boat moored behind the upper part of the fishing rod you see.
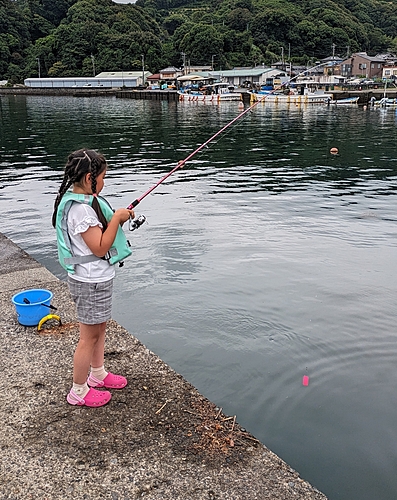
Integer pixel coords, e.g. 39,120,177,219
248,87,332,106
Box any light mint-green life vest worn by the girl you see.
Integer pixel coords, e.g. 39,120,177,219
55,191,132,274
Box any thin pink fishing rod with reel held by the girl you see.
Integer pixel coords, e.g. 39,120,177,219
127,63,328,212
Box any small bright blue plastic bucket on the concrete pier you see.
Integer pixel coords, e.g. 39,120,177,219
11,288,52,326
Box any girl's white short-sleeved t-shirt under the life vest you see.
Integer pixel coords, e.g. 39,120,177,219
68,203,116,283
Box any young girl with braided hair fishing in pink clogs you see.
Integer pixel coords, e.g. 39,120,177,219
52,149,134,407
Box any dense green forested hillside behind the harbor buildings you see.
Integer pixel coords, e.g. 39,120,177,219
0,0,397,83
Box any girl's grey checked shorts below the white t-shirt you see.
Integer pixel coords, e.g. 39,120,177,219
68,276,113,325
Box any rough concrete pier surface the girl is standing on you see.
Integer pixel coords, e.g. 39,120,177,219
0,234,326,500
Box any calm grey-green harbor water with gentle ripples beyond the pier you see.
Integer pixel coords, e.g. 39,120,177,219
0,96,397,500
